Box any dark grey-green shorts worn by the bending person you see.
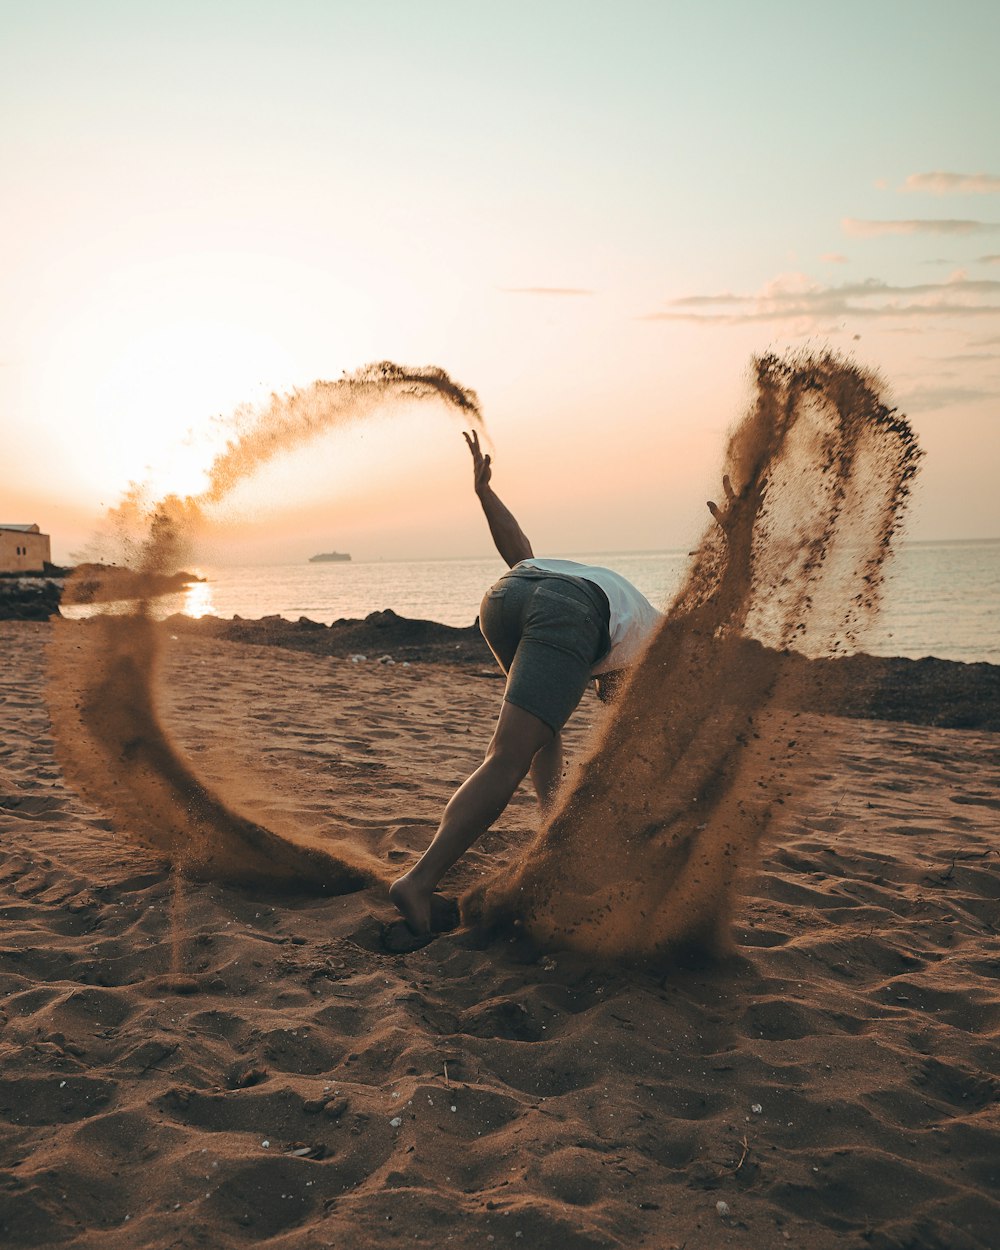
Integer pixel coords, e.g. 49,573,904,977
479,569,611,733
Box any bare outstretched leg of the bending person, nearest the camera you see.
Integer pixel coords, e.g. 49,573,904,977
389,701,554,934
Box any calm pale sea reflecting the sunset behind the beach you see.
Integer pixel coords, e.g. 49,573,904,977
66,540,1000,664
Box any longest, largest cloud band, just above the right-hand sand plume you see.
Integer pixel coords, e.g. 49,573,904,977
640,271,1000,325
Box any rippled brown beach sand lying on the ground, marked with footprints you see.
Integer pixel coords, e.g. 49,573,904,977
0,623,1000,1250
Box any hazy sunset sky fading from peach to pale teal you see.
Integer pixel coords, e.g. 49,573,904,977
0,0,1000,563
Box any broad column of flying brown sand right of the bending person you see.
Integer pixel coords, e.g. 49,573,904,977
463,354,920,961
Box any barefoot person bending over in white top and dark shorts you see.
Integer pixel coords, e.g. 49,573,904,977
389,433,661,936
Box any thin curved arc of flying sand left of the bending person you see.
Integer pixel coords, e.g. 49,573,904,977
48,361,483,894
